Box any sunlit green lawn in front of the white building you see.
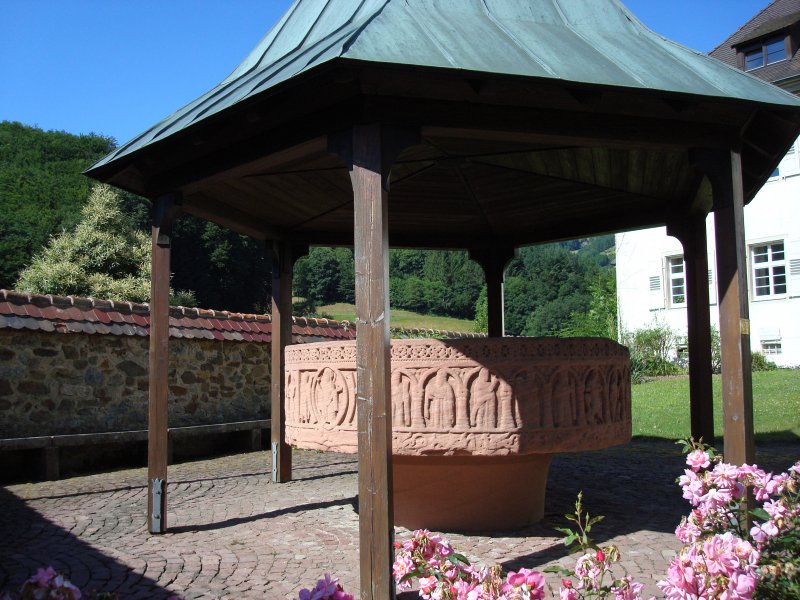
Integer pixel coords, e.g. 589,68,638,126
632,369,800,441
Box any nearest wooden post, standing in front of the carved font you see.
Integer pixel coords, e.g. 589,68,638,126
329,124,419,600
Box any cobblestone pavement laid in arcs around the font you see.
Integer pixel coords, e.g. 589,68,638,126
0,441,800,599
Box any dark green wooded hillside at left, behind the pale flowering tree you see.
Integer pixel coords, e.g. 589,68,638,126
0,121,270,312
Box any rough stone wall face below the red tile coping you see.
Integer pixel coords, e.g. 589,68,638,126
0,328,270,437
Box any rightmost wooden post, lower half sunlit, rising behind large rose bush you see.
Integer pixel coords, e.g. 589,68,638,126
698,151,755,465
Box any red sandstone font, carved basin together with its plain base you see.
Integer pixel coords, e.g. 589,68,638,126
286,338,631,531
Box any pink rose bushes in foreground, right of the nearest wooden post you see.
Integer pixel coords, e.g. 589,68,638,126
394,440,800,600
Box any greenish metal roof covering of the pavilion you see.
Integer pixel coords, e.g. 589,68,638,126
90,0,800,167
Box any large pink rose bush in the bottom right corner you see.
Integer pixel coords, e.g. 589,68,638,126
657,440,800,600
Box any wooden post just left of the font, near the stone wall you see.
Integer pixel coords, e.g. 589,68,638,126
270,241,308,483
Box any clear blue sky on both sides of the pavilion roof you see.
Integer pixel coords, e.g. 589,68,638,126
0,0,768,143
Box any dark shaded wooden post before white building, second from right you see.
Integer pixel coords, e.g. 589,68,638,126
667,218,714,444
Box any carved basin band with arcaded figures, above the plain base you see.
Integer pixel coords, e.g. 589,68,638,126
286,339,630,454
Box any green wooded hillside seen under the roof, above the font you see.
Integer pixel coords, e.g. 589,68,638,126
295,235,616,335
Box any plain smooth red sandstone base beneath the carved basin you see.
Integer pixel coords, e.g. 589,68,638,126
393,454,552,531
